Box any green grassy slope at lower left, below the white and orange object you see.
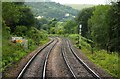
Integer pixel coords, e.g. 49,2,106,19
2,39,37,71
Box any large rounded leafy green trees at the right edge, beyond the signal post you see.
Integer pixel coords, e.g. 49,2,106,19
88,2,120,52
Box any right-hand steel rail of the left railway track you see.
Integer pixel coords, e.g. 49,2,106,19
42,39,58,79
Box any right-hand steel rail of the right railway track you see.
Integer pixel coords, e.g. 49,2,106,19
66,40,101,79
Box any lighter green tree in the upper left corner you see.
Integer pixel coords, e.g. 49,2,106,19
2,2,20,32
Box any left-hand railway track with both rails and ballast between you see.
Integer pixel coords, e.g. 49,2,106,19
17,38,58,79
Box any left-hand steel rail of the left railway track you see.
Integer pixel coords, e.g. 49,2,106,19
17,39,54,79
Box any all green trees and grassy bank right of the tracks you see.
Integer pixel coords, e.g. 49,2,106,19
66,2,120,77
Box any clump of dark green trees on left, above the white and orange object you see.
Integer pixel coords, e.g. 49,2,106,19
2,2,47,45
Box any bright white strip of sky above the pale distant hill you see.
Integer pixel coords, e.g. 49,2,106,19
52,0,108,4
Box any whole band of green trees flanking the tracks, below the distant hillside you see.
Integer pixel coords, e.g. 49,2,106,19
2,2,120,52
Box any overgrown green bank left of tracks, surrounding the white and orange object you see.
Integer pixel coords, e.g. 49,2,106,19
0,23,49,72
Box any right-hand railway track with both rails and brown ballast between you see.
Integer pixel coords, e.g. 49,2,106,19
61,39,101,79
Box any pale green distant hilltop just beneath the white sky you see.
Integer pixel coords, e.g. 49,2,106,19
64,4,95,10
